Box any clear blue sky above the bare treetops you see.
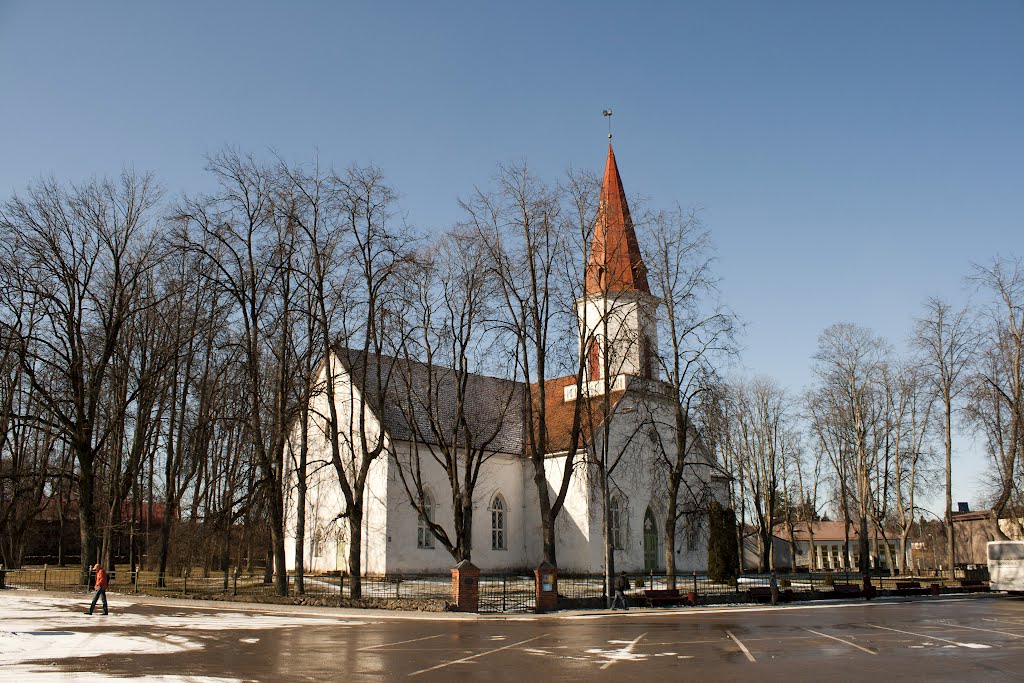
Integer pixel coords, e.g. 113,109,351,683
0,0,1024,504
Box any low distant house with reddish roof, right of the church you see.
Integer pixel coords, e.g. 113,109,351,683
776,521,909,571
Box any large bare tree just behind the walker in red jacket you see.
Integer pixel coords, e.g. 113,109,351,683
0,172,159,574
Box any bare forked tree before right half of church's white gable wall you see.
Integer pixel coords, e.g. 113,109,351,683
290,166,415,599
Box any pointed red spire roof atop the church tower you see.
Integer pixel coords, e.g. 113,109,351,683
586,142,650,296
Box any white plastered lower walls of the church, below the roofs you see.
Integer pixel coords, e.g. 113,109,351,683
286,350,725,574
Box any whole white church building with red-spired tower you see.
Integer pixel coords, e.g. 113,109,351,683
286,144,727,575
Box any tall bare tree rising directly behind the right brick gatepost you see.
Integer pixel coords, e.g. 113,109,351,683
462,165,598,569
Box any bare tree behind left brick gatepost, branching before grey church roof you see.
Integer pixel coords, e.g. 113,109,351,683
394,228,525,562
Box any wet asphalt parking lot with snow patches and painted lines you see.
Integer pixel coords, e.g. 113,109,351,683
0,592,1024,681
